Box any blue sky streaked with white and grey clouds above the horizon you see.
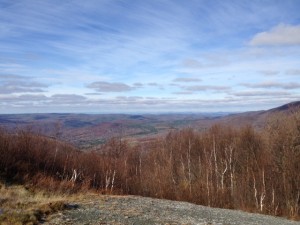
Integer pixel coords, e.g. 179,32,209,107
0,0,300,114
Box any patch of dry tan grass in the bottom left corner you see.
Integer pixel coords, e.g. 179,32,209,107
0,182,80,225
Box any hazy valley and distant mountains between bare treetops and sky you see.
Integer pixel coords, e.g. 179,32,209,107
0,101,300,148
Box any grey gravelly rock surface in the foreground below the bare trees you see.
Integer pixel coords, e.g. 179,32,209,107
44,195,300,225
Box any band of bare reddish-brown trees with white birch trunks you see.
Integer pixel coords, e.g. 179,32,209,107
0,112,300,219
